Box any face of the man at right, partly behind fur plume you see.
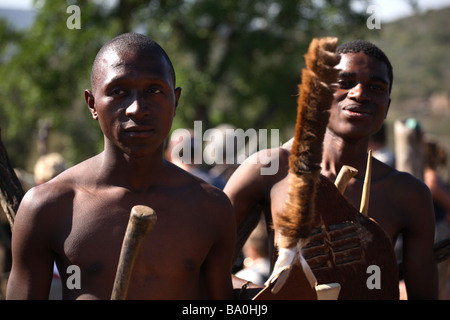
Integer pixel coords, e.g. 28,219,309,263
328,52,391,140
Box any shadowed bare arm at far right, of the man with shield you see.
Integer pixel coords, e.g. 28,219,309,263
403,182,438,299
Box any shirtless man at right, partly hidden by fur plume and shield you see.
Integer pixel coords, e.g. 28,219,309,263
224,41,437,299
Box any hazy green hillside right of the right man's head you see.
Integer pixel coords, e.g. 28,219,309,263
367,8,450,181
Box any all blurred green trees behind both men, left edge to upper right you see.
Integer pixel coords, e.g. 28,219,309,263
0,0,366,169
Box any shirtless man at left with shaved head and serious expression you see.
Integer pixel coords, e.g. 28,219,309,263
7,33,235,299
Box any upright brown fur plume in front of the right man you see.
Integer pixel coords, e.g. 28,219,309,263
278,38,340,248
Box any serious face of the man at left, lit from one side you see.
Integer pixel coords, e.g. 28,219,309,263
85,50,181,156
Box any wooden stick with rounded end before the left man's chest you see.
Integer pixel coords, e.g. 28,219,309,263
111,205,156,300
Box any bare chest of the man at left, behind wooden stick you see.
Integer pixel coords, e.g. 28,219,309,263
52,186,213,298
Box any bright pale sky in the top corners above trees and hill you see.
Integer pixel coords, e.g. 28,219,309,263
0,0,450,22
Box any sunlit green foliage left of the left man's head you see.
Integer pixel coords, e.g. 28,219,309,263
0,1,119,169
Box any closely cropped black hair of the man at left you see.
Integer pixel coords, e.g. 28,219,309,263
91,32,176,89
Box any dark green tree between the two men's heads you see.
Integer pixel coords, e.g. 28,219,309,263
148,0,365,129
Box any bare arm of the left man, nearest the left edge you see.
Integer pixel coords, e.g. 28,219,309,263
6,186,54,300
